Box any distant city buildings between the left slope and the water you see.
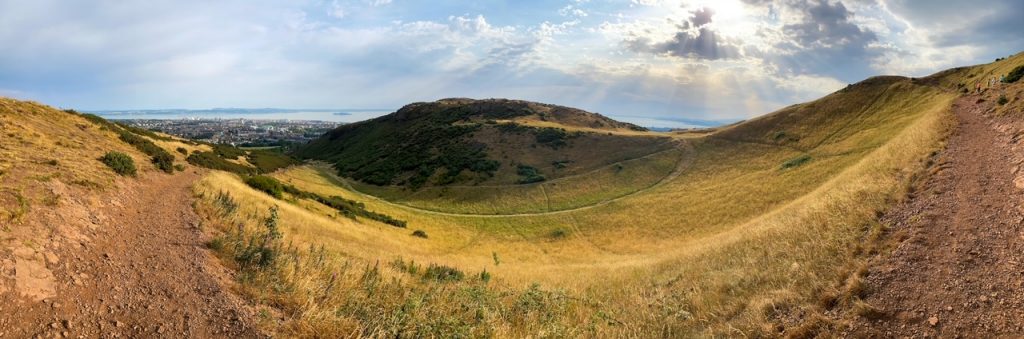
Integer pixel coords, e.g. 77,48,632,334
117,118,344,146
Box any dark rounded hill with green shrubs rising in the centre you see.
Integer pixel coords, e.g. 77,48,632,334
295,98,670,188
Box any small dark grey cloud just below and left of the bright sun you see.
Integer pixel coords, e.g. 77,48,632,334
626,8,741,60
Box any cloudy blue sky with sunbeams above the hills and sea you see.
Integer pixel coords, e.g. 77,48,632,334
0,0,1024,125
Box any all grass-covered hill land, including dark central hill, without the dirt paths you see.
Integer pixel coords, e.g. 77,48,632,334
0,51,1024,337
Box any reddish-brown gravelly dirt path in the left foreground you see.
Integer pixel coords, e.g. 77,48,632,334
0,172,261,338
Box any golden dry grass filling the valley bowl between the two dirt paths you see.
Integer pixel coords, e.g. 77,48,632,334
188,61,978,337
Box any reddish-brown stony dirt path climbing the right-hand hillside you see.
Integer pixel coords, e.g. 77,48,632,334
852,96,1024,338
